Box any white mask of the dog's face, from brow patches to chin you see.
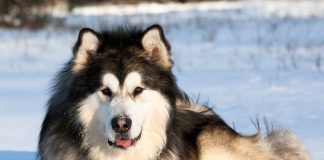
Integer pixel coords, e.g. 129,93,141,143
96,71,153,149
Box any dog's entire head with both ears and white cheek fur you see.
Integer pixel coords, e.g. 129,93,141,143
72,25,175,155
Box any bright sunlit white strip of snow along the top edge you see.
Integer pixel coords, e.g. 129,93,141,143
69,0,324,18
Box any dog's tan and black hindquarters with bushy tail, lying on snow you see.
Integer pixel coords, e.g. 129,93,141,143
178,100,310,160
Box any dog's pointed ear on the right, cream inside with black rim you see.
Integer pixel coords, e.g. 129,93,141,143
141,25,172,69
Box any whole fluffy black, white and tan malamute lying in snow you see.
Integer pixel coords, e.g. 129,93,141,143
38,25,309,160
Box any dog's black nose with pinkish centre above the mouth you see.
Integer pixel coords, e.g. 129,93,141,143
111,116,132,133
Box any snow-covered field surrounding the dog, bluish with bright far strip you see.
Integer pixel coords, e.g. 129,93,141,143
0,0,324,160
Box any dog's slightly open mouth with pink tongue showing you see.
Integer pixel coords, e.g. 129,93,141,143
108,132,142,149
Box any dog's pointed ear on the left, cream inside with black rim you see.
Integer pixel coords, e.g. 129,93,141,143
73,28,100,72
